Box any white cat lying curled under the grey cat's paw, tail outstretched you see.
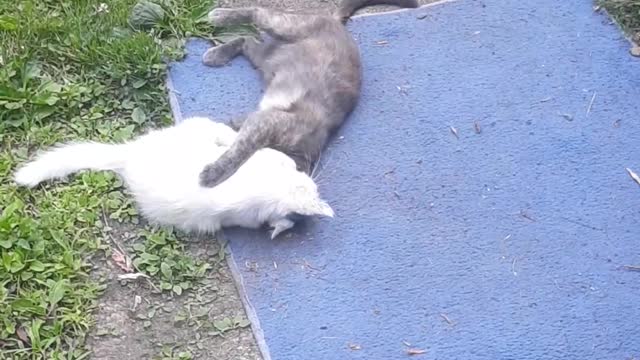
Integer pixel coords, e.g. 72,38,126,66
15,117,334,239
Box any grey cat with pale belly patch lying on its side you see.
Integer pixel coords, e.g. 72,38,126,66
200,0,418,187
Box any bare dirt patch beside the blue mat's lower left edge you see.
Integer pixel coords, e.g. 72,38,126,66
88,231,261,360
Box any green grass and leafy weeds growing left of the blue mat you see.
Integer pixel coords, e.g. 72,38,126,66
0,0,222,359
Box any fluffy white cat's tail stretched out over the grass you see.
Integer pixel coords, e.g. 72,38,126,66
14,142,126,187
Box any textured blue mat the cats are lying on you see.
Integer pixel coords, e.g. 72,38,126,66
171,0,640,360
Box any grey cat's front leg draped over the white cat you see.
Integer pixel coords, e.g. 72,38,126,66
200,111,277,188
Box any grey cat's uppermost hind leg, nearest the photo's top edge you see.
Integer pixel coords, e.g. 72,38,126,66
209,7,330,41
